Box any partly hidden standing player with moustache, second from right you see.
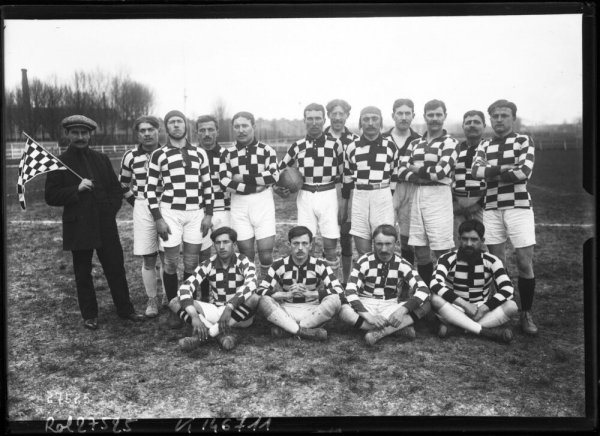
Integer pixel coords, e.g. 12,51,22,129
452,110,485,247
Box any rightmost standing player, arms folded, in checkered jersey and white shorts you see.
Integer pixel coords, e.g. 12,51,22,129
473,100,538,335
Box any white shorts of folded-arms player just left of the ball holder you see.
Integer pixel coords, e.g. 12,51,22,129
231,188,275,241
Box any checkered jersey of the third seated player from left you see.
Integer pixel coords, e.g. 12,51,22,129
346,252,429,312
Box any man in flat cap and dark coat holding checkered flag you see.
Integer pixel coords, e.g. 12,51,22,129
45,115,145,330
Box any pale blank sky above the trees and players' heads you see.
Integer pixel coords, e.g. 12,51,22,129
4,15,582,129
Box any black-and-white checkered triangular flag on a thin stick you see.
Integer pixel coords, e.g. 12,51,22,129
17,137,68,210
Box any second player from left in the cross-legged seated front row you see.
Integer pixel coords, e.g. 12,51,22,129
257,226,344,342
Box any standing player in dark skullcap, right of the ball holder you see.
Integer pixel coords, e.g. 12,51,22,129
340,106,399,256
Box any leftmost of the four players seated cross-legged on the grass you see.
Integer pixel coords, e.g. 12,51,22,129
169,227,259,351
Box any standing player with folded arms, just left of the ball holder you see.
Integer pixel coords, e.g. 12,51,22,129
219,112,279,276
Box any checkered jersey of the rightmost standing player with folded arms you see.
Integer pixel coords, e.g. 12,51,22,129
472,132,535,210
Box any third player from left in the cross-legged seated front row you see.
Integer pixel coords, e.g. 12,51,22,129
340,224,431,346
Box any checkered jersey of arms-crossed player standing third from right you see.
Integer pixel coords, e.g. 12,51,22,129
398,130,458,185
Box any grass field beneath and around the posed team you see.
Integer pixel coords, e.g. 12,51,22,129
5,146,595,426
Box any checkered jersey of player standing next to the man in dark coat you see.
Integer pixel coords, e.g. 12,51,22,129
119,144,163,200
